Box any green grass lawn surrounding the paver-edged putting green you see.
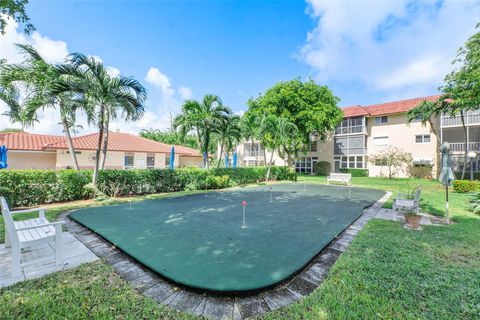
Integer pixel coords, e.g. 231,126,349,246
0,177,480,319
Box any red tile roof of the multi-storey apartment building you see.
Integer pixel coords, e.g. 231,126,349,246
342,95,440,117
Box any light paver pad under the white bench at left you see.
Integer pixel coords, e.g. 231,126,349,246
0,232,98,288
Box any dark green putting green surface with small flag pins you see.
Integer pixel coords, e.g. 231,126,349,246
70,183,384,292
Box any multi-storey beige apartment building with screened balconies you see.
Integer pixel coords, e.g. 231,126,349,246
223,96,452,177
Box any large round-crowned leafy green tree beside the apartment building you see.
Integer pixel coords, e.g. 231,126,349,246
246,79,343,165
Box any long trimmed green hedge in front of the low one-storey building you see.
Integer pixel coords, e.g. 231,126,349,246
0,167,296,207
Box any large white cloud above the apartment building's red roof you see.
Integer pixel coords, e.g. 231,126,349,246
298,0,480,95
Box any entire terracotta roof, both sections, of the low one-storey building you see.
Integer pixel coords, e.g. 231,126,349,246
0,132,201,156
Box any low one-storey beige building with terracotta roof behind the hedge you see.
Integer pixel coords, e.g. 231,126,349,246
0,132,203,169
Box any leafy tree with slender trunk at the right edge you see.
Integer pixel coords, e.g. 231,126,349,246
440,23,480,179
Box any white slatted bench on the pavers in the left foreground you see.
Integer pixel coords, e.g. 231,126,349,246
0,197,64,277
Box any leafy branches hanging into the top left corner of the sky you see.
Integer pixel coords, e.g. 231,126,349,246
0,0,35,35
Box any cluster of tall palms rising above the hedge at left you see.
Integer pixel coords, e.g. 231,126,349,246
0,45,146,185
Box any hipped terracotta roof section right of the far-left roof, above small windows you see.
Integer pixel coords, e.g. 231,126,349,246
46,132,200,156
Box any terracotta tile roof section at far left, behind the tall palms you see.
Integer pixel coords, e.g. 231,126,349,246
0,132,65,151
